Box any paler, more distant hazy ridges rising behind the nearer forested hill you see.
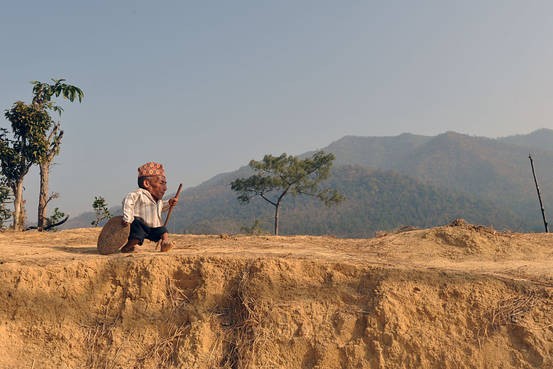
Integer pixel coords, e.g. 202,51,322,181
323,130,553,230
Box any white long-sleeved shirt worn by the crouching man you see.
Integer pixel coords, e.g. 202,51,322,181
123,188,169,227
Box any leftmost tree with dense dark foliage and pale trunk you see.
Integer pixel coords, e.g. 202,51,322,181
0,101,52,230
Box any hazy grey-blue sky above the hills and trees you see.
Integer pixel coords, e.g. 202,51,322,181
0,0,553,218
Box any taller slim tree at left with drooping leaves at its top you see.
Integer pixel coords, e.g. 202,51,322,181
32,79,84,231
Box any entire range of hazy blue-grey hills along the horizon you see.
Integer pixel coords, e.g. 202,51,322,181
67,129,553,237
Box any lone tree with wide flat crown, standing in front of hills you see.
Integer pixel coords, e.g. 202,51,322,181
231,151,343,235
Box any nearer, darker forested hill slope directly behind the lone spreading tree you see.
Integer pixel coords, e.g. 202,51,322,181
66,166,527,237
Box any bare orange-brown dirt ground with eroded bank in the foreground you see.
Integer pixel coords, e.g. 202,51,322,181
0,222,553,369
